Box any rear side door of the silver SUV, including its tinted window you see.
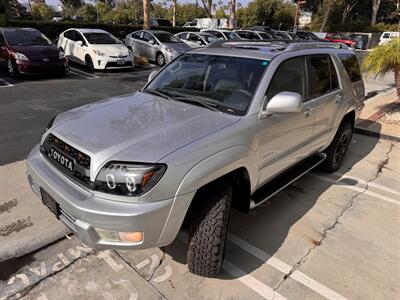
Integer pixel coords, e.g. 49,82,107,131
307,54,343,145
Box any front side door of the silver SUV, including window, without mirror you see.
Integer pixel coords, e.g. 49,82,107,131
258,56,315,185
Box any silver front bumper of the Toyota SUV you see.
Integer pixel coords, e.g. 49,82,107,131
27,146,177,250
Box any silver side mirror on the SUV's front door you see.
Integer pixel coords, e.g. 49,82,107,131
262,92,303,117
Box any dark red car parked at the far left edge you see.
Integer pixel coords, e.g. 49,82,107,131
0,28,69,77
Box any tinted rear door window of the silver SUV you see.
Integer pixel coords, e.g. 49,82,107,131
308,55,331,98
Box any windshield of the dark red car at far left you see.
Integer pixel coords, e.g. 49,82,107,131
4,29,52,46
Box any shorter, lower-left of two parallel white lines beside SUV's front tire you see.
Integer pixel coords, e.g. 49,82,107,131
178,231,286,300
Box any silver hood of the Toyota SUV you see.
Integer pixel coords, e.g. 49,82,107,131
49,92,240,175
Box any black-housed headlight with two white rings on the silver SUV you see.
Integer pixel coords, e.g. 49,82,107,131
95,162,167,197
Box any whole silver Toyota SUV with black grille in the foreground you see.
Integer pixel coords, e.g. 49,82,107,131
27,41,364,277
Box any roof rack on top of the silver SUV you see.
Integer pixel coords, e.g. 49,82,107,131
207,39,349,52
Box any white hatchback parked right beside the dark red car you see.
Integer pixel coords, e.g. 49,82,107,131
57,28,134,70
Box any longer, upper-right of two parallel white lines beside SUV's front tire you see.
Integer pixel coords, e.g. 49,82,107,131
228,233,347,300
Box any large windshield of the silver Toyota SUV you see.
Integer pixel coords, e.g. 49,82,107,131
145,53,269,115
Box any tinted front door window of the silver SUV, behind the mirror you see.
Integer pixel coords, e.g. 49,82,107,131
267,57,306,100
